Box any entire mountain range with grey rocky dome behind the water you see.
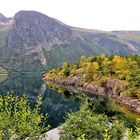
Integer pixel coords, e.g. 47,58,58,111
0,11,140,71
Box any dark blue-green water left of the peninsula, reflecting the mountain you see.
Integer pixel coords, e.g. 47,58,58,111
0,73,79,127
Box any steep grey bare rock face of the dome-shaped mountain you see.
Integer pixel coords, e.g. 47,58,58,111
8,11,71,48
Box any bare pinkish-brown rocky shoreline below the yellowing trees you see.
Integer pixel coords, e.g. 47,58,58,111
44,76,140,113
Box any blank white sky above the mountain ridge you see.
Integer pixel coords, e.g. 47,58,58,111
0,0,140,31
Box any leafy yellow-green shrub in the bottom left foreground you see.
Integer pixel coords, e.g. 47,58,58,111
0,93,48,140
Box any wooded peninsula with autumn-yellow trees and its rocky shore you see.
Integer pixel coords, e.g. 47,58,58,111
43,54,140,113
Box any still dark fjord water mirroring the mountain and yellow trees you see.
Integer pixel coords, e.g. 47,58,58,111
0,73,140,127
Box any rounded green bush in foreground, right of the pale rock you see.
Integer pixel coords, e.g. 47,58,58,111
60,101,125,140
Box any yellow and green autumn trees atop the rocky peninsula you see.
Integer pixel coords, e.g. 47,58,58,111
46,54,140,98
